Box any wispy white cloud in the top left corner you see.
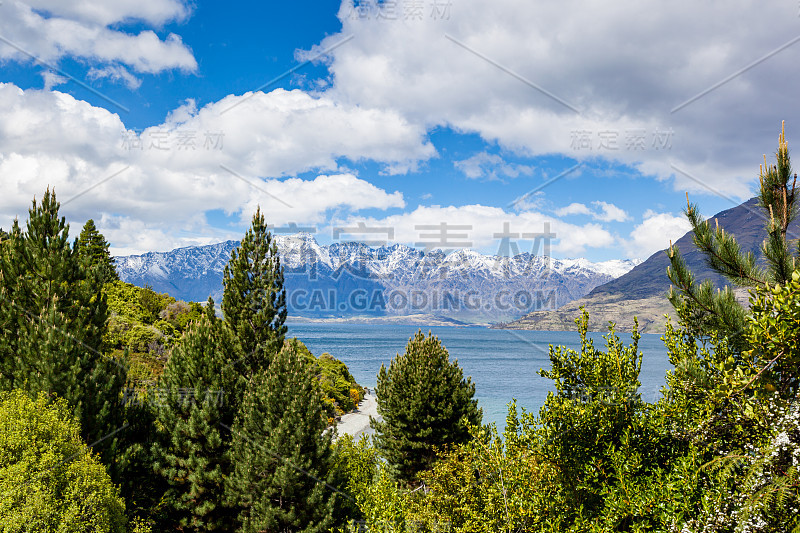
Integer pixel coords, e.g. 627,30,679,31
0,0,197,75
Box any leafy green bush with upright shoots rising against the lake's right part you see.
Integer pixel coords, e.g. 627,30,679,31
535,311,685,531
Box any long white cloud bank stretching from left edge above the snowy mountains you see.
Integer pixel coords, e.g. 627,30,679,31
0,84,424,251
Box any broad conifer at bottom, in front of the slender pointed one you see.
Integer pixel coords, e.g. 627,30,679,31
228,347,342,533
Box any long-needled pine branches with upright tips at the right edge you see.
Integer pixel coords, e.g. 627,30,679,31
667,121,800,352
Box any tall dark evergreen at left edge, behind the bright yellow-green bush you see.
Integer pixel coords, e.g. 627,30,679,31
0,190,126,461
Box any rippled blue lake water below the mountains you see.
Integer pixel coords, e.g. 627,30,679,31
288,323,672,431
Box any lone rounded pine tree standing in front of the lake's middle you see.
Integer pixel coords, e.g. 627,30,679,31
372,331,482,483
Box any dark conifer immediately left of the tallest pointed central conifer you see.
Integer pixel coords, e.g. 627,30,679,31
151,298,242,531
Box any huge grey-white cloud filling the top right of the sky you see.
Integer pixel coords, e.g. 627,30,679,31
320,0,800,198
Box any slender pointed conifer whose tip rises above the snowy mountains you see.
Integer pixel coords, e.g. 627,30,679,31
222,208,286,375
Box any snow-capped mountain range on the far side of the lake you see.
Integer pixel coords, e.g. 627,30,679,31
116,233,638,324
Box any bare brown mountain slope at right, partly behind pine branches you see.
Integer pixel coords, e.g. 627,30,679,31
505,198,800,332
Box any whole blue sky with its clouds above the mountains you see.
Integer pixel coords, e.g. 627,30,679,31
0,0,800,261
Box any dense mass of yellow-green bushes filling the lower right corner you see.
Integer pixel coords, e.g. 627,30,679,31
342,290,800,533
